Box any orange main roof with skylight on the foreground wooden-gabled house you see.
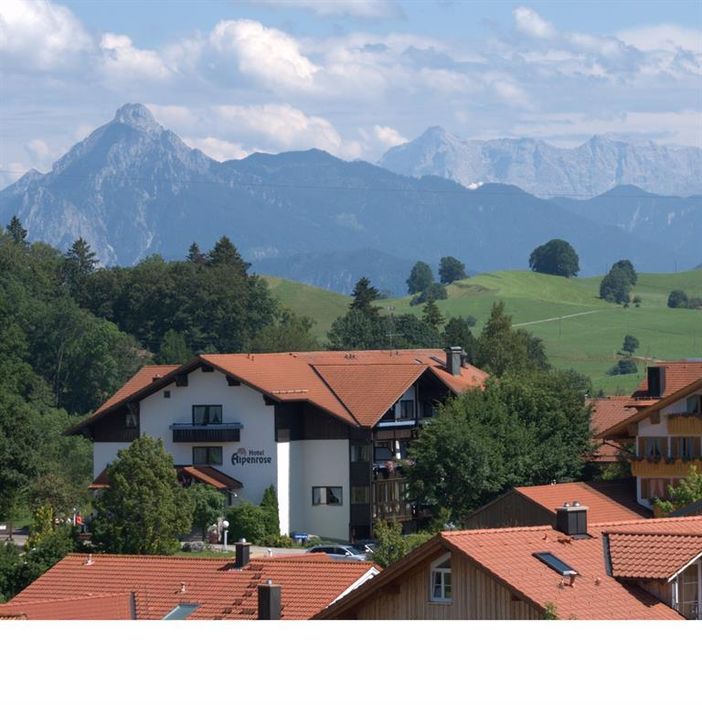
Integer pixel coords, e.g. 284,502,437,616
317,517,702,619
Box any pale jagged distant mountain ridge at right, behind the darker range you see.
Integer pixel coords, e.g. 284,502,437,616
378,127,702,198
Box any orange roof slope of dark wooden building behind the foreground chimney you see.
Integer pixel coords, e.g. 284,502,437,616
514,480,651,524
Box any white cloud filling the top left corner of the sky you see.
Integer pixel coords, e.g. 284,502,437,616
0,0,93,71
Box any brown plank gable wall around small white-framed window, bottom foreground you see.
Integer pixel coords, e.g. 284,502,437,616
350,549,541,619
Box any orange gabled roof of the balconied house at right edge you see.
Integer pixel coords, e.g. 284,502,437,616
596,361,702,438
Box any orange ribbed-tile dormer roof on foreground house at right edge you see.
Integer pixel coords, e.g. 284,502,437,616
605,522,702,580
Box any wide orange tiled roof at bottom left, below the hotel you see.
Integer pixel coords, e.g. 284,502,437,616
6,554,377,619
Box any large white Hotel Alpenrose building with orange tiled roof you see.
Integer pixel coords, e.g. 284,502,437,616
69,348,487,540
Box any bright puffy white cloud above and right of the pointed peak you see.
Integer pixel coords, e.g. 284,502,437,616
210,20,319,89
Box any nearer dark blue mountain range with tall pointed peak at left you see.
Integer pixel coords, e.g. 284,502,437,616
0,104,702,293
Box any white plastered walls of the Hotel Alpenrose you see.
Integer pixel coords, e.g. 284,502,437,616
93,368,350,540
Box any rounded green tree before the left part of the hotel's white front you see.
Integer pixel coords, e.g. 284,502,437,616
93,436,193,554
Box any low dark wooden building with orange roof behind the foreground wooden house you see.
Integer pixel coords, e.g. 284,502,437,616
462,479,651,529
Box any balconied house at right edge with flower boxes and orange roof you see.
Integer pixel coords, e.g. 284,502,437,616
598,361,702,507
